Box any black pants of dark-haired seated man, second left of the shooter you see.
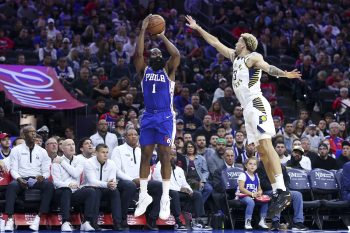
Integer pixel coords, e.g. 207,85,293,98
94,188,122,224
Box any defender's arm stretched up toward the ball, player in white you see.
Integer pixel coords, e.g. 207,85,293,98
186,15,235,59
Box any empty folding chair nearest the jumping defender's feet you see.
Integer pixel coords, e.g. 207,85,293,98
287,168,322,229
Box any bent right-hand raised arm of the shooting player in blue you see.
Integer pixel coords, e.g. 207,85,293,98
157,31,181,80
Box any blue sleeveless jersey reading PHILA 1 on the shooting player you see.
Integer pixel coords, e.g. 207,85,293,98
141,66,175,112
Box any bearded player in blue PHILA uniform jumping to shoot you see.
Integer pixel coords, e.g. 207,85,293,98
134,15,180,220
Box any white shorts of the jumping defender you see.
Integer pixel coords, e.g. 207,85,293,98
243,96,276,146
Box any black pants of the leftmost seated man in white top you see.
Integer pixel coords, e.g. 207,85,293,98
5,179,55,215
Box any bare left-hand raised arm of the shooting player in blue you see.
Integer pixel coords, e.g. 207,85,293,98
134,15,152,73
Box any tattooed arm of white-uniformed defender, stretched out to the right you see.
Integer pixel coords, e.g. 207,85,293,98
249,53,301,78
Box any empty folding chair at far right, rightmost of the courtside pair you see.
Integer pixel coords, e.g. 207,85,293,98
309,169,350,229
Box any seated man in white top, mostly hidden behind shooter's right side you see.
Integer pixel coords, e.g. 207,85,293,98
153,148,212,231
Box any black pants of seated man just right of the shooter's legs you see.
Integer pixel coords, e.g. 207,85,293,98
169,190,205,218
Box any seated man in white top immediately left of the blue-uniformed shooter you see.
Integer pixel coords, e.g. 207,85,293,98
112,128,162,230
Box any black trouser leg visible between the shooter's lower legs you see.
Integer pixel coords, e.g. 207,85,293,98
146,180,163,219
